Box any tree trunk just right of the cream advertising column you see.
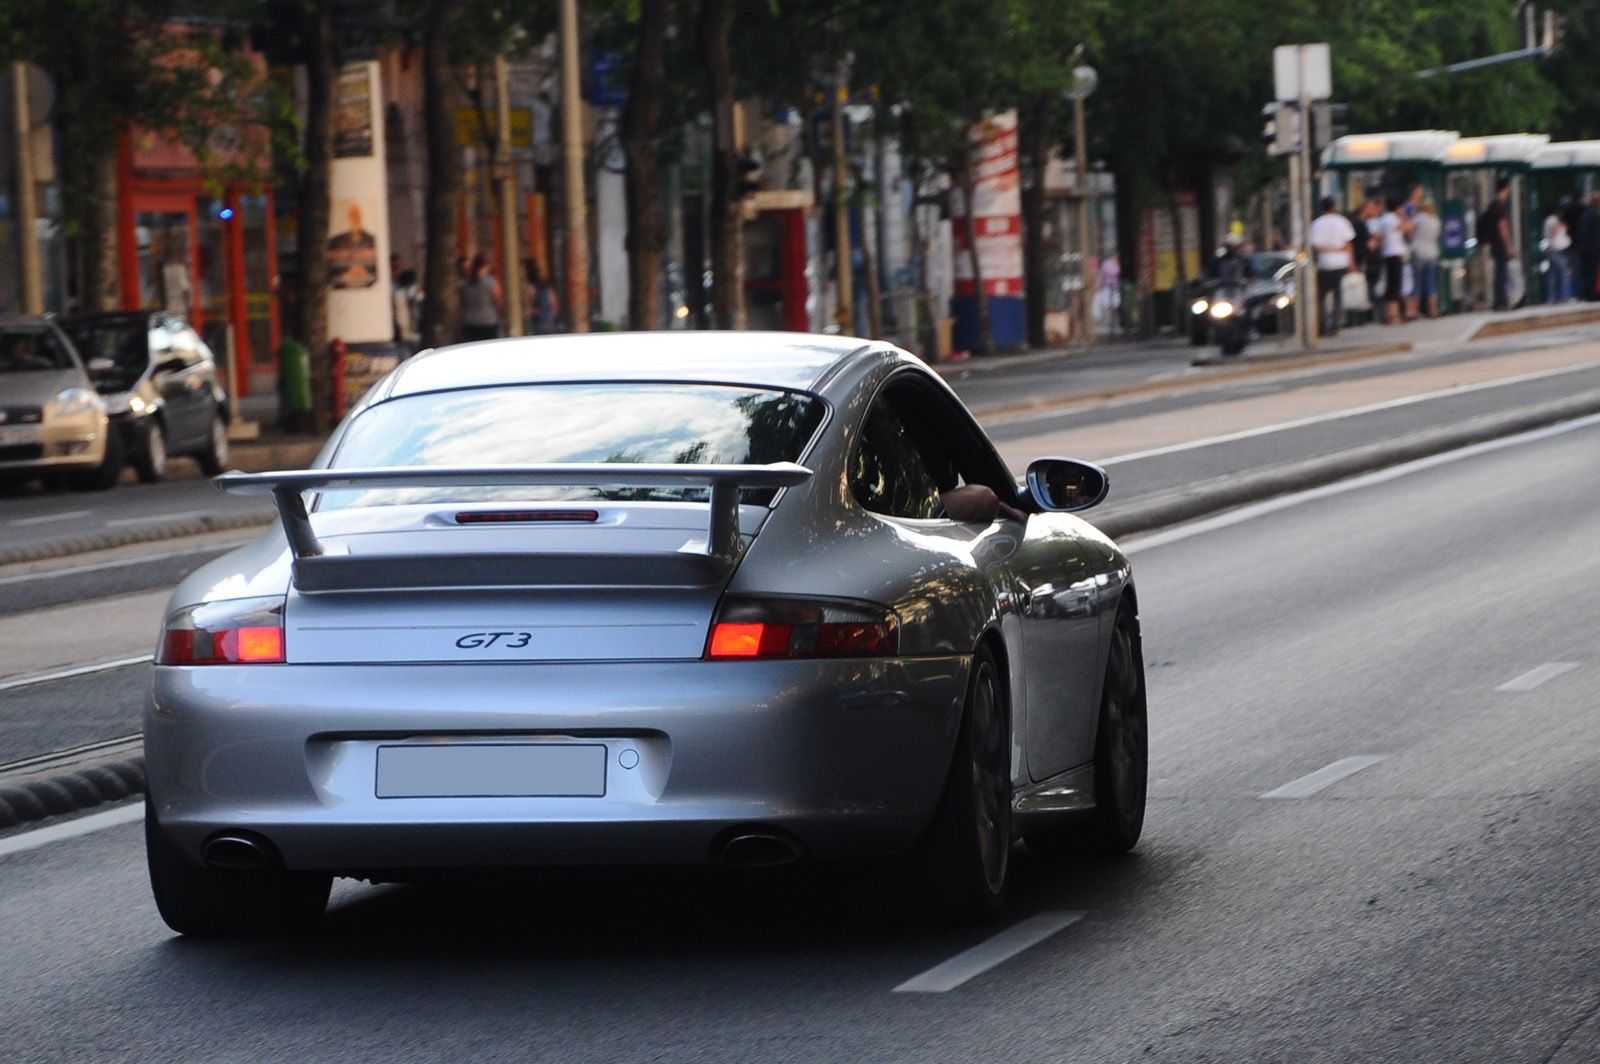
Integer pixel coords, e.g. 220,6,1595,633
421,0,462,347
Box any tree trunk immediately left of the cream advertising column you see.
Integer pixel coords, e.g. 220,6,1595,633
296,3,339,434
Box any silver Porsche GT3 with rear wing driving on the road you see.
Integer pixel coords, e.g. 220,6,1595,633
144,333,1147,934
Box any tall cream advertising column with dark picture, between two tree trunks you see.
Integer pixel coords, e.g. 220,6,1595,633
328,62,394,346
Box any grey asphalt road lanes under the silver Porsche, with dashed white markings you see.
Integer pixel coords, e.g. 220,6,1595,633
0,404,1600,1064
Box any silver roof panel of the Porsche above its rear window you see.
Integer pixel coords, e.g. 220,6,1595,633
384,331,886,398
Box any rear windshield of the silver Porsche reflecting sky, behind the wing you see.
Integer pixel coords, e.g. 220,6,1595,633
318,382,824,509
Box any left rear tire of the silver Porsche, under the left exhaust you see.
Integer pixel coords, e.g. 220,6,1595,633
144,797,333,938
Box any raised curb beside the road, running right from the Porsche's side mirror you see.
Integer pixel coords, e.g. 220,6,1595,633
1086,389,1600,538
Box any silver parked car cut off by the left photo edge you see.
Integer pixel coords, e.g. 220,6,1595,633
0,317,123,491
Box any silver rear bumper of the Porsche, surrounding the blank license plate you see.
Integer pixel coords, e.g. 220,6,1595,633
144,658,968,872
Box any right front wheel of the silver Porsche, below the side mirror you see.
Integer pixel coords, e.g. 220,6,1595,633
1024,605,1150,861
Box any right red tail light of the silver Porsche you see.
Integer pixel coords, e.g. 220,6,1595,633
706,598,899,661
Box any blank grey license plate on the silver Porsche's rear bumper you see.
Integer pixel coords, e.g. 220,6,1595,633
378,742,606,798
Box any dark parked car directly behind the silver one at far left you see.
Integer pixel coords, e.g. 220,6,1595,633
62,310,227,483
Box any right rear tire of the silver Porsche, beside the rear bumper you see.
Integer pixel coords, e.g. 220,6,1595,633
909,646,1011,923
